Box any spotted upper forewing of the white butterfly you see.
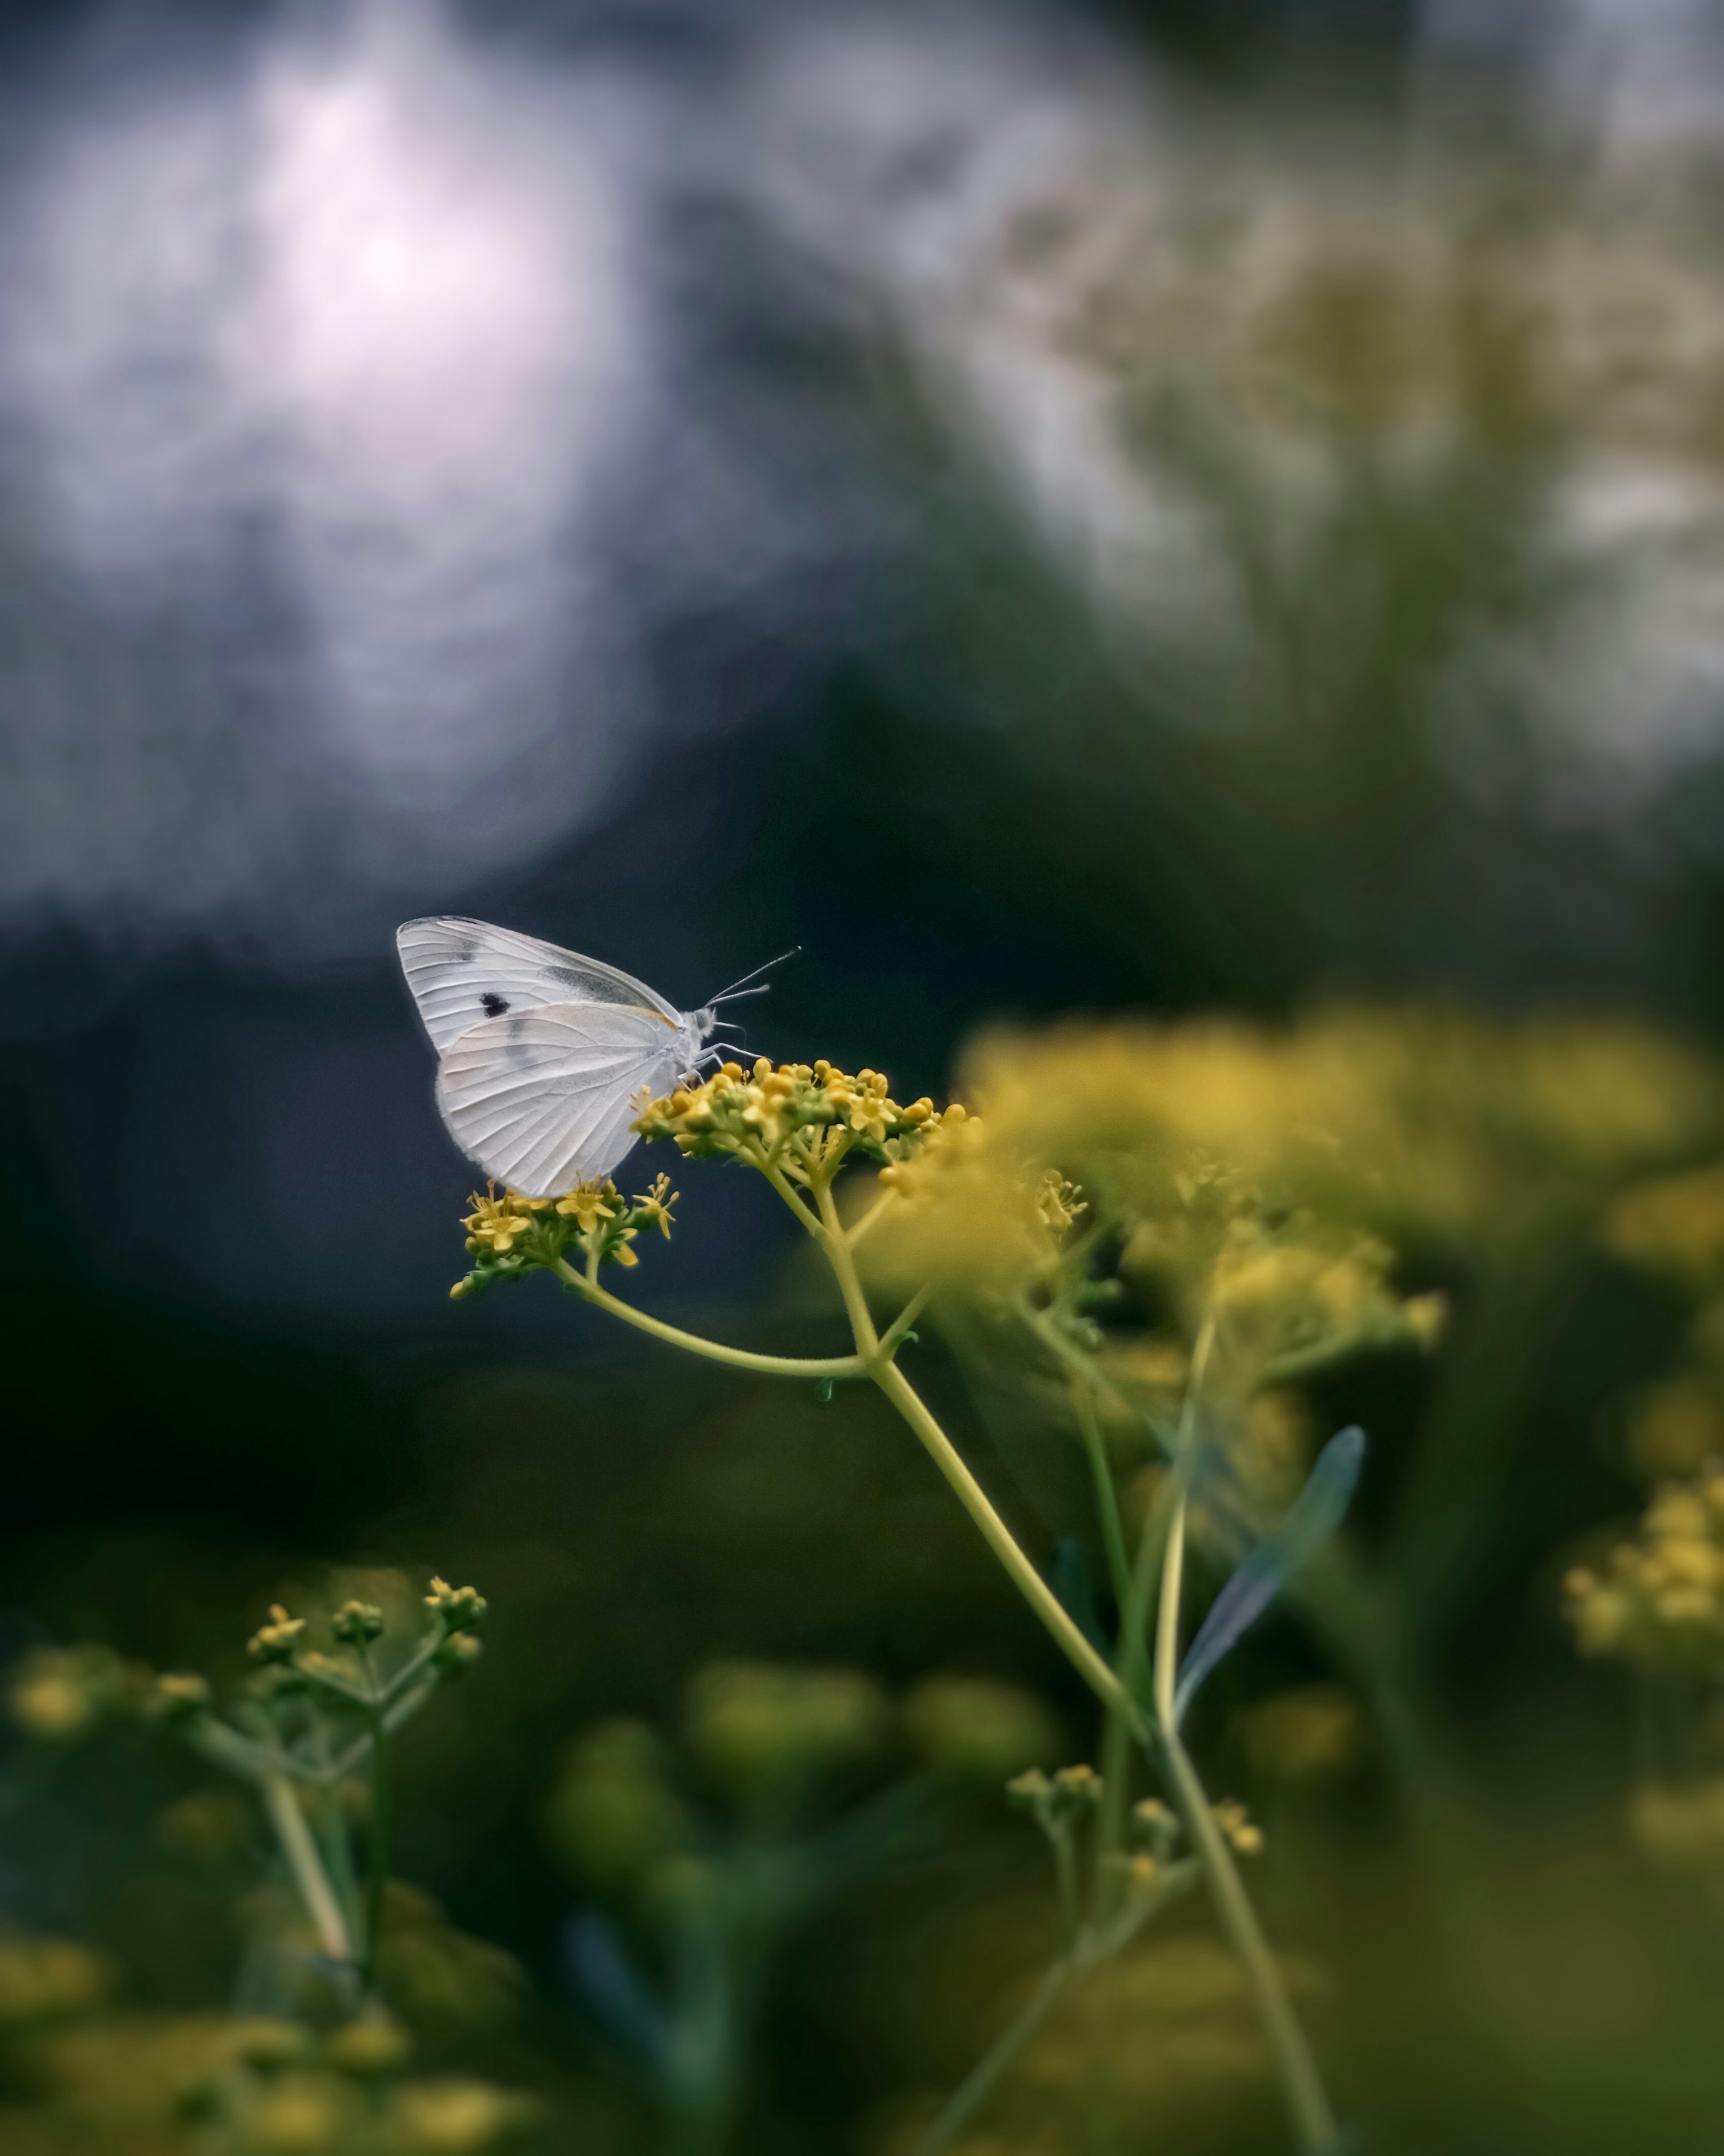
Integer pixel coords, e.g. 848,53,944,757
394,914,679,1052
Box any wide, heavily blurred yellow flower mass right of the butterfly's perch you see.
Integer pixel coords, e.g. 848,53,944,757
881,1009,1724,1315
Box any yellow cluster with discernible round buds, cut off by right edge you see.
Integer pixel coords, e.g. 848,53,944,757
1562,1462,1724,1675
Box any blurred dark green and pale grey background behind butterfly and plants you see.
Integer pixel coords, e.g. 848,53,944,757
0,0,1724,2156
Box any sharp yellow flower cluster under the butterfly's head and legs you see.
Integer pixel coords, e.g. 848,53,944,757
633,1056,963,1184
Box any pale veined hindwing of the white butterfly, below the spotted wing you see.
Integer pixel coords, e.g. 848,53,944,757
437,1002,681,1199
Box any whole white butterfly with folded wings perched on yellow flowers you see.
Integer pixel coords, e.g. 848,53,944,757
394,918,759,1199
